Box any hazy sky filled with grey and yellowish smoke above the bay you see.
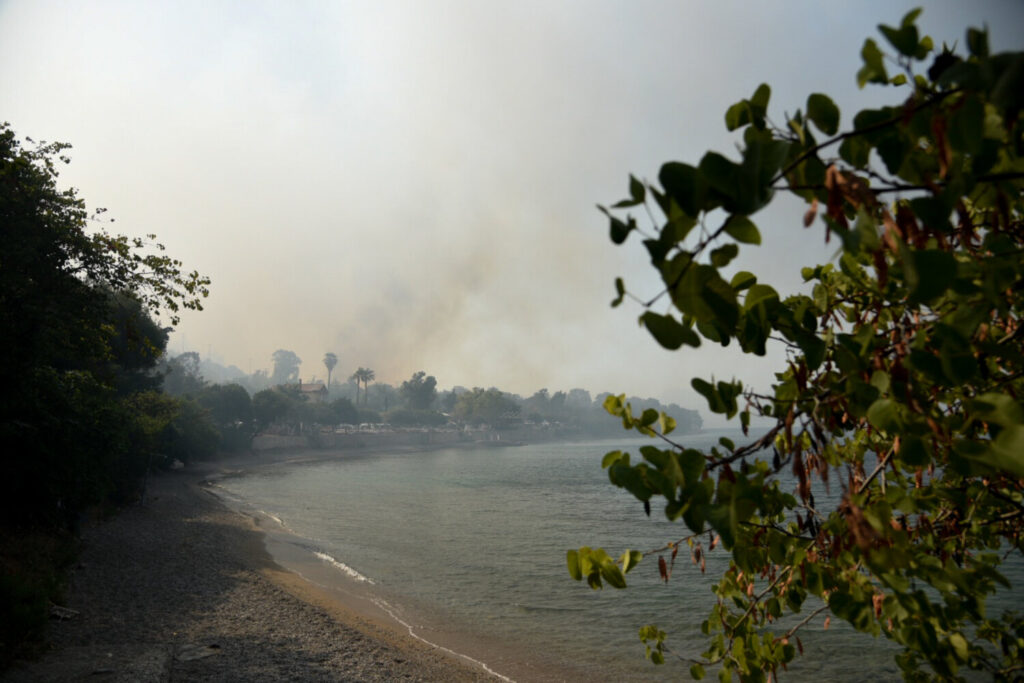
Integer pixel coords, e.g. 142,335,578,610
0,0,1024,421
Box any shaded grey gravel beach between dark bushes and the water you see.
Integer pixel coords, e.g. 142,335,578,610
3,464,495,683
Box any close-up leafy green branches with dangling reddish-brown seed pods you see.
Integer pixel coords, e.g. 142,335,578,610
568,11,1024,680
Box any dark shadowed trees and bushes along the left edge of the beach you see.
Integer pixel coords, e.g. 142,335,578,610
0,124,209,667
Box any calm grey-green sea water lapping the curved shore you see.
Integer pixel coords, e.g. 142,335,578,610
214,431,1015,681
